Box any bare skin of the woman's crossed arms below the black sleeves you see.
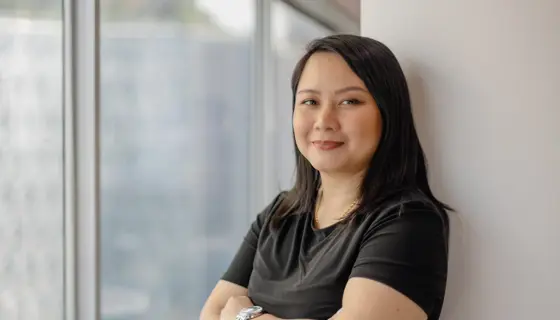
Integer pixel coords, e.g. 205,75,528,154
200,277,428,320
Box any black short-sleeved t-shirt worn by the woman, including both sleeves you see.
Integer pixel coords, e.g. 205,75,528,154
222,193,448,320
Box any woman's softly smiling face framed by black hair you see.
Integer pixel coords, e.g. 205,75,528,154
293,52,382,174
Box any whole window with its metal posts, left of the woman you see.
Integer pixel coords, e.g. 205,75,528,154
0,0,356,320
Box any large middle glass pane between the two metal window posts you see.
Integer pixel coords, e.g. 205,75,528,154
101,0,255,320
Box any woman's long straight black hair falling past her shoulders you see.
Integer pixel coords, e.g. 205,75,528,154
272,34,452,226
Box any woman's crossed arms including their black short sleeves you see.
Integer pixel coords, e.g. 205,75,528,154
200,202,447,320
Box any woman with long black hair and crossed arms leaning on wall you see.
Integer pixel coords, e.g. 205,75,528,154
200,35,449,320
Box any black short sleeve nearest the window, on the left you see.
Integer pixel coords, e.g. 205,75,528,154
221,193,283,288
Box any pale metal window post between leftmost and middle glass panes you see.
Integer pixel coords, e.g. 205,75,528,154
63,0,100,320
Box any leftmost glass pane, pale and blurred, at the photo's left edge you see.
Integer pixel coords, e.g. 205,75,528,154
0,0,64,320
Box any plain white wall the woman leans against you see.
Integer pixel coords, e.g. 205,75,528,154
361,0,560,320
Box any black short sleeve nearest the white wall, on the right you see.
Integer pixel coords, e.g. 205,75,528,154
350,209,448,315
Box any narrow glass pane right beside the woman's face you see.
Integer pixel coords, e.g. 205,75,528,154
266,1,332,190
